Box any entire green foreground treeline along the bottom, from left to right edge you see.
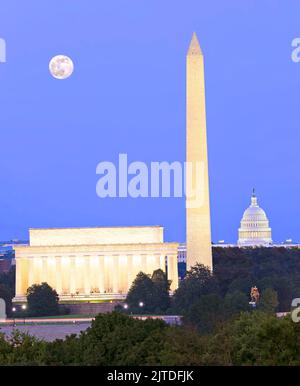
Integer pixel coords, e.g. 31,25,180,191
0,311,300,366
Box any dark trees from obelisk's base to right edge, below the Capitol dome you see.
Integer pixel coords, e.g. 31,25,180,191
173,247,300,333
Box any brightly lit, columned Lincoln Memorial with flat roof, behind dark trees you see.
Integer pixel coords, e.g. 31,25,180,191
14,226,178,301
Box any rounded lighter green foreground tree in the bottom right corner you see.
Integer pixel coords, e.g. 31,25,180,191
205,311,300,366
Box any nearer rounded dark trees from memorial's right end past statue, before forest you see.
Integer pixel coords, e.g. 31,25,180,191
122,264,278,334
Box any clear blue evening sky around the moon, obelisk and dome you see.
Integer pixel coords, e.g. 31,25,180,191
0,0,300,241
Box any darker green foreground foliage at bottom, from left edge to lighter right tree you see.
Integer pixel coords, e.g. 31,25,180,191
0,312,206,366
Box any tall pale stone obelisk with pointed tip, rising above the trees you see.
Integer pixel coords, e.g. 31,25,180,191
186,33,212,269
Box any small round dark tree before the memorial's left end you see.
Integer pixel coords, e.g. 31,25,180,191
27,283,59,316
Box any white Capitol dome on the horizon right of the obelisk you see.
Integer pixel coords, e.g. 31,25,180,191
238,189,272,246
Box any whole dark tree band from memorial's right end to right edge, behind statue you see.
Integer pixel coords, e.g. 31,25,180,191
123,248,300,334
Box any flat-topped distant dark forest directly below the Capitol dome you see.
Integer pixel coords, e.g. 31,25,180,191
213,247,300,311
